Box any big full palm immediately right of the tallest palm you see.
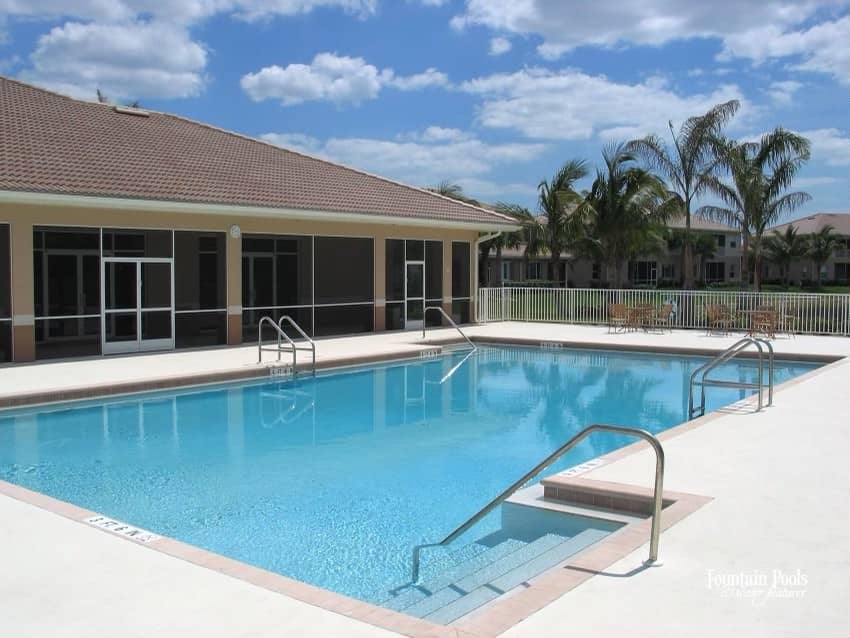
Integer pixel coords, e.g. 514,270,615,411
699,127,811,291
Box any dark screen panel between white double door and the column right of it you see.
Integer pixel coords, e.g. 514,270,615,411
174,231,227,348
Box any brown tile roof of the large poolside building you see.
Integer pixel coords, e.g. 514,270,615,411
0,76,511,226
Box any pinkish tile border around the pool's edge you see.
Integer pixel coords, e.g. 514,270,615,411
0,338,850,638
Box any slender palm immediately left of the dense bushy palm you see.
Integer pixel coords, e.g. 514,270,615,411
537,160,587,287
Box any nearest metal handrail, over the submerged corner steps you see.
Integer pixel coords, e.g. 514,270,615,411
412,423,664,583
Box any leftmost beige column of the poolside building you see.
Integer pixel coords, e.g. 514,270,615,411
9,222,35,362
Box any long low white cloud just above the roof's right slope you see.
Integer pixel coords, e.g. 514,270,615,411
261,127,547,185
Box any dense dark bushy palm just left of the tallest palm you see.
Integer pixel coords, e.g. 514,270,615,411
576,144,678,287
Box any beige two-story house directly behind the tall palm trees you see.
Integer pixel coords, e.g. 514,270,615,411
488,215,742,288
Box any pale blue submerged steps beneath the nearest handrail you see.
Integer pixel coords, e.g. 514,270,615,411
384,529,609,624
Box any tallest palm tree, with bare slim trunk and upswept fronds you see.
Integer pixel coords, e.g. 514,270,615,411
627,100,740,289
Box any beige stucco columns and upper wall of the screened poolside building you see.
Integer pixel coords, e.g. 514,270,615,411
0,203,478,361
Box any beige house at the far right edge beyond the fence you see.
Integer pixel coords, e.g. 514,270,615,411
763,212,850,284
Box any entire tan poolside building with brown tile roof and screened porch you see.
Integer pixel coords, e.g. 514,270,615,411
0,77,515,361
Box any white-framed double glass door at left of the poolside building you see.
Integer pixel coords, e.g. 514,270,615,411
101,257,174,354
